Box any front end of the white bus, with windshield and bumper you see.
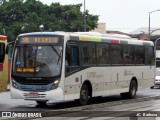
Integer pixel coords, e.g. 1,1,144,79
10,32,63,104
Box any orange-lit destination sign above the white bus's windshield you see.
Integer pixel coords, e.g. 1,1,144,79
19,36,59,44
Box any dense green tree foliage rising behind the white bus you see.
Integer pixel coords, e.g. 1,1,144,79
0,0,98,41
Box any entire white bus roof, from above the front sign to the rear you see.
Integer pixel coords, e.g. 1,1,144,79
18,31,154,46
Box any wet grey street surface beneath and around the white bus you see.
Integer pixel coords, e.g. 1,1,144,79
0,88,160,120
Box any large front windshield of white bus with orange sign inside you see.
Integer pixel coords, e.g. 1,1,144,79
13,45,62,77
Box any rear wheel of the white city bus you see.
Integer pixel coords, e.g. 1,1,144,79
127,80,137,99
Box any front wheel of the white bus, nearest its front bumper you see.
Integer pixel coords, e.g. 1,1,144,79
79,84,89,105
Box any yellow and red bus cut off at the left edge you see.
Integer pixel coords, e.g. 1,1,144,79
0,35,9,92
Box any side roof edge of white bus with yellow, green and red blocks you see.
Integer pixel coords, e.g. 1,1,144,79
70,33,154,46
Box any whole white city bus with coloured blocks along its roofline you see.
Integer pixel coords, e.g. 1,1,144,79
10,31,155,105
